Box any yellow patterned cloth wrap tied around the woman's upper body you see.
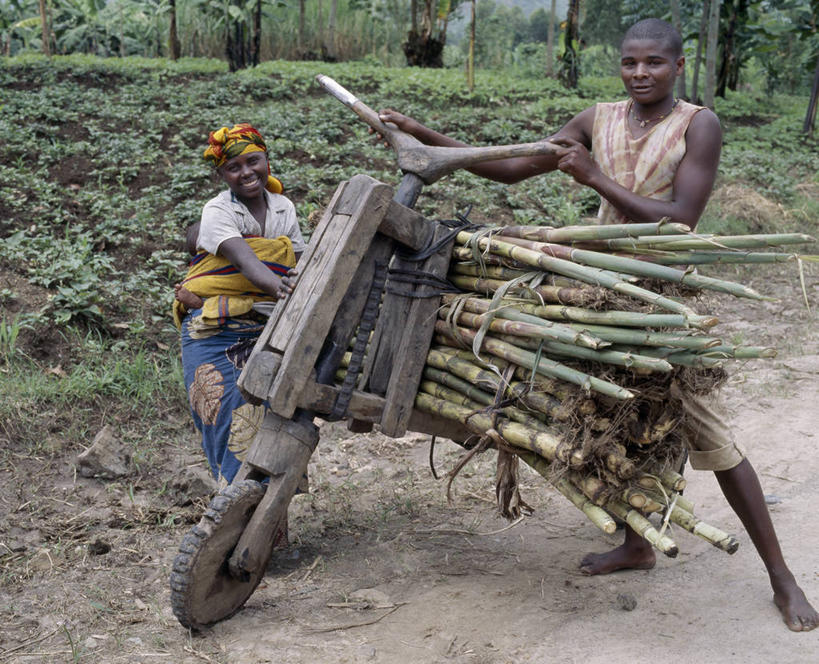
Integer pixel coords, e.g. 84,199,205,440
173,235,296,333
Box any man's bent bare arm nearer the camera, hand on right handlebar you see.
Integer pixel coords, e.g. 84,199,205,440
555,109,722,228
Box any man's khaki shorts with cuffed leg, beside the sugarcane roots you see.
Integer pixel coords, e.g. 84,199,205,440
670,381,745,470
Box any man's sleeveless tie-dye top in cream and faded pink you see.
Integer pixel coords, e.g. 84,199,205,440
592,99,703,224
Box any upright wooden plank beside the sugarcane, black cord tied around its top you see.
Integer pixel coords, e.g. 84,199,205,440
373,225,455,437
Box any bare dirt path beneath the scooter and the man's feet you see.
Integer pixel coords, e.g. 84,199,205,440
0,266,819,664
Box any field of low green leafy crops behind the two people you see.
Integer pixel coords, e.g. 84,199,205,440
0,56,819,456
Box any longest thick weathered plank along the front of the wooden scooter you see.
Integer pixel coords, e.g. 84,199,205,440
267,175,392,417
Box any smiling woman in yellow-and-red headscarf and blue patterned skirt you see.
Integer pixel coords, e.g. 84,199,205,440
174,124,305,485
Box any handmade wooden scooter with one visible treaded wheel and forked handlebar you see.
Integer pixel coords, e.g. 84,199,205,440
170,76,559,630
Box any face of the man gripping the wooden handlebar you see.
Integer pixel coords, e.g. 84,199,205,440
620,39,685,105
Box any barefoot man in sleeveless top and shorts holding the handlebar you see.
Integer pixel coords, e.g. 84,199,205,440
380,19,819,631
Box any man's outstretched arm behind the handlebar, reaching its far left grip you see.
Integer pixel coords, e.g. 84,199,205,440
379,106,594,184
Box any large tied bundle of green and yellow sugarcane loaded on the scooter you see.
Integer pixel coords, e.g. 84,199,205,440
342,222,816,556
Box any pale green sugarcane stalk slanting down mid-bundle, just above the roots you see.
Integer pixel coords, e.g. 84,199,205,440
435,320,634,399
